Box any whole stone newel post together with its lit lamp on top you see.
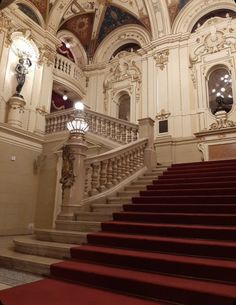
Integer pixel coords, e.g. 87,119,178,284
58,102,89,219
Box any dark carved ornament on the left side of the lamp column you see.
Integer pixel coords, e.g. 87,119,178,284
60,145,75,198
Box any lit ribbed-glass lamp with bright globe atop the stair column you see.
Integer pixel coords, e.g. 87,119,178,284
67,102,89,142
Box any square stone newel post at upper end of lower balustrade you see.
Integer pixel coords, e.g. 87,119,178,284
138,118,157,169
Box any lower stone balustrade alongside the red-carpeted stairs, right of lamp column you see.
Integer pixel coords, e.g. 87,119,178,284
84,138,148,198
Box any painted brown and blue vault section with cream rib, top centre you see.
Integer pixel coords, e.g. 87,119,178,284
59,0,151,58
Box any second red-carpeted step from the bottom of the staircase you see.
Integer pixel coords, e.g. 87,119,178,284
71,245,236,283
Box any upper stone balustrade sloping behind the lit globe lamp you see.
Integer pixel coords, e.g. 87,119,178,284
45,109,139,144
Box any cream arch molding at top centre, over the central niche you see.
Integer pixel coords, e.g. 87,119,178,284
93,25,151,63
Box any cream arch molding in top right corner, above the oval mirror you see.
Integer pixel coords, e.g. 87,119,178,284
173,0,236,34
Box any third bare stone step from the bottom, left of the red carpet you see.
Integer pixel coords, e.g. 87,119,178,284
34,229,88,244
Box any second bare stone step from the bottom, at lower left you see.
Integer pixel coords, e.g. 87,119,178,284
13,236,75,259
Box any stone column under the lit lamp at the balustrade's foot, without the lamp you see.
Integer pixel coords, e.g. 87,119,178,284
58,137,88,219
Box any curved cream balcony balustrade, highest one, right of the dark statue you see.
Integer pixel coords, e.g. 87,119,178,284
54,54,86,88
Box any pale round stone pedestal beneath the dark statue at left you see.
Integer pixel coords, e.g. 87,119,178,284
7,95,26,128
